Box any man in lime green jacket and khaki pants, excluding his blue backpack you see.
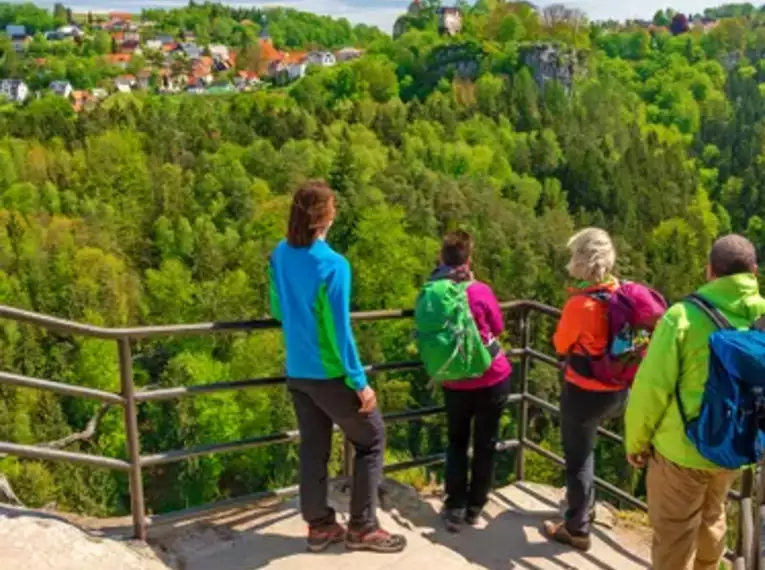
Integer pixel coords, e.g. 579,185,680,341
626,235,765,570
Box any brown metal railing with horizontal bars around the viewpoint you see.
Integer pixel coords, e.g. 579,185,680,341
0,301,765,570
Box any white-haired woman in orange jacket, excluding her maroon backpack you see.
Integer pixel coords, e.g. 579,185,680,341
544,228,628,551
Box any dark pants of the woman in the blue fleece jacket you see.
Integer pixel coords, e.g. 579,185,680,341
287,378,385,531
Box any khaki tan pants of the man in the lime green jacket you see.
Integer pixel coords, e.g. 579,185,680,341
647,453,739,570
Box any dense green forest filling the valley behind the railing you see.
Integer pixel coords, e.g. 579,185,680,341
0,0,765,515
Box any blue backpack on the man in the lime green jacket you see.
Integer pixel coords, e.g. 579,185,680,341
675,294,765,470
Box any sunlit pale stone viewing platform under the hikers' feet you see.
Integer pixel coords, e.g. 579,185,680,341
0,483,650,570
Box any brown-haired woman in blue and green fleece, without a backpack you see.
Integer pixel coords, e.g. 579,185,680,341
269,181,406,553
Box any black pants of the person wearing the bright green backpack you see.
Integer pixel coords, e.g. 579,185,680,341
444,379,510,509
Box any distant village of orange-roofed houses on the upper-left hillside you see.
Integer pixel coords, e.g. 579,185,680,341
0,9,368,105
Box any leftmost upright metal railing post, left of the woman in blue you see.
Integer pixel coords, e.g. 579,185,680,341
117,337,146,540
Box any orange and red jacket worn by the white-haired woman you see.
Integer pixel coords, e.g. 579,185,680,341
553,279,623,392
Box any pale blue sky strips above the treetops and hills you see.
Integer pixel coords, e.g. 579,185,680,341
11,0,724,32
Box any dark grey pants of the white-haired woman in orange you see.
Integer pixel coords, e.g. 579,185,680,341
560,382,628,535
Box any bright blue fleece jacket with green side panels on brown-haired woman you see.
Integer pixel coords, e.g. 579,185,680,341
269,240,367,390
